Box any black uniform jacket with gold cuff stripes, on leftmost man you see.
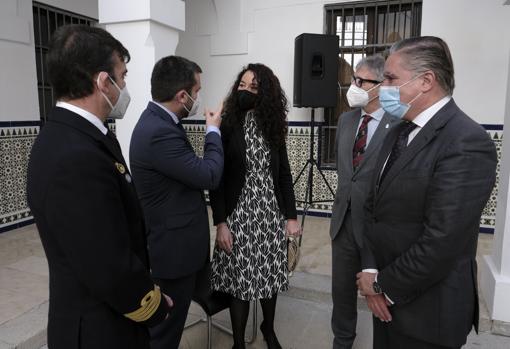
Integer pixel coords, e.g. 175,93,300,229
27,107,168,349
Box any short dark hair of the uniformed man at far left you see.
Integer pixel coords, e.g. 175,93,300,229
46,25,131,99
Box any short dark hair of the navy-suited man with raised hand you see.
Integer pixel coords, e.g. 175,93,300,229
151,56,202,103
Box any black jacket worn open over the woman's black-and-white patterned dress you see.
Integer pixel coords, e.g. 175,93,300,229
209,116,297,225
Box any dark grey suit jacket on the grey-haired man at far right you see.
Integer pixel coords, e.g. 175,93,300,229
364,99,497,347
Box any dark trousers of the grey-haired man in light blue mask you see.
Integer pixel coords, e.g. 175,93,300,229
372,317,460,349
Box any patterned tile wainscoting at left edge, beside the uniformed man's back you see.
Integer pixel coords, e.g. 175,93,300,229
0,121,39,232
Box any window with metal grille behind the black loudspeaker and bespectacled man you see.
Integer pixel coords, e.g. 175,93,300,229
321,0,422,167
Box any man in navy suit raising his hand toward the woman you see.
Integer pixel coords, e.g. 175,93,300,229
130,56,223,349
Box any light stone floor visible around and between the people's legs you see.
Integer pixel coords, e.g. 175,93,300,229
0,211,510,349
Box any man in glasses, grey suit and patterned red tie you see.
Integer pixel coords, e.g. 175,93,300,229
330,56,398,349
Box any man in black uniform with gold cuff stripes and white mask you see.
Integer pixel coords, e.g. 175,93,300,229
27,26,171,349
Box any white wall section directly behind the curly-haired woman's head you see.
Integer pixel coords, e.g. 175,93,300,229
176,0,342,120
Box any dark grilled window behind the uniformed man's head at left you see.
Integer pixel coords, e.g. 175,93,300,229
33,1,97,124
